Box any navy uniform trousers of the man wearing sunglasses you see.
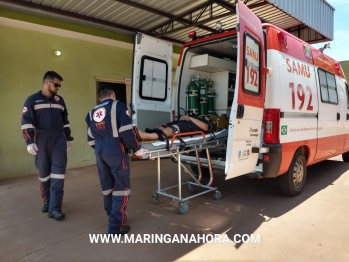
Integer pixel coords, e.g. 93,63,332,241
35,130,67,212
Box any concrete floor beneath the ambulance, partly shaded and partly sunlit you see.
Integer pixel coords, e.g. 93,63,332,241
0,158,349,261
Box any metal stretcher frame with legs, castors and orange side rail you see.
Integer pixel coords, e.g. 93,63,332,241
140,131,227,214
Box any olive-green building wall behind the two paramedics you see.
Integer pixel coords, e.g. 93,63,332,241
0,21,177,179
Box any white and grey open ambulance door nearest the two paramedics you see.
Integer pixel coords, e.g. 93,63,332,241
130,33,172,130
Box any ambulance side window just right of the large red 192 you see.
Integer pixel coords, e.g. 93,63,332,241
319,69,338,104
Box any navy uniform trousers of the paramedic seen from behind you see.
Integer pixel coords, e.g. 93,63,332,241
95,138,131,234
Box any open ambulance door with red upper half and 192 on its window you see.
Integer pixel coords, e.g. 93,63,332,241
225,0,265,179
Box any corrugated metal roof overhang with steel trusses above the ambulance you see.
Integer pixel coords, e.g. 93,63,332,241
0,0,334,44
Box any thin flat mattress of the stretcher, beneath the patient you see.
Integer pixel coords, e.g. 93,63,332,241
141,129,228,152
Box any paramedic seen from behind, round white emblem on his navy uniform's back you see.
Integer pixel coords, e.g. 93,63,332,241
85,86,145,234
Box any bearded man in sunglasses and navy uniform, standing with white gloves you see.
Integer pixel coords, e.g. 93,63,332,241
21,71,73,219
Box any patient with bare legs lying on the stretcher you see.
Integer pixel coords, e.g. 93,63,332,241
134,115,217,142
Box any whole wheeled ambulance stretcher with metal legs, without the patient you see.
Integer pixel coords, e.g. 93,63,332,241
135,129,228,214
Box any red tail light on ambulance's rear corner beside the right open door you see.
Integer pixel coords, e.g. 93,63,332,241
264,108,280,144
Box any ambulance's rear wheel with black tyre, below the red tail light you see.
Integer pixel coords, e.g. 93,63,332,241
279,151,307,196
